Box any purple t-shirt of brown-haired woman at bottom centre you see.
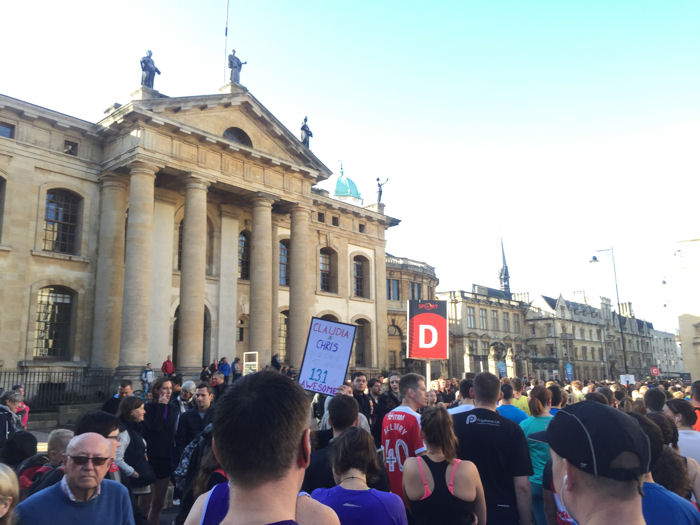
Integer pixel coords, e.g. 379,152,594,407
311,486,408,525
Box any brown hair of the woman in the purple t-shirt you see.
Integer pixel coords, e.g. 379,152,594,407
331,427,381,483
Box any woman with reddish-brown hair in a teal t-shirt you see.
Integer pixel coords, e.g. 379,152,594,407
520,385,552,525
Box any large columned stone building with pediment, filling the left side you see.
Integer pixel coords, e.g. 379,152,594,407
0,85,398,376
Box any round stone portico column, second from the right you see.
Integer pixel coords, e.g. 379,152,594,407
248,194,273,368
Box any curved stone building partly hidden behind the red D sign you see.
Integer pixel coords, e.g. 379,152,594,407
386,254,440,375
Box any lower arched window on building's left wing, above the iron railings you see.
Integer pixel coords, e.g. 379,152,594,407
34,286,74,358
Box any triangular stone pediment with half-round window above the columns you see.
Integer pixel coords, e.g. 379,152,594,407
104,86,331,180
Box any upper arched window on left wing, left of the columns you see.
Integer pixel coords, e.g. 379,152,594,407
42,189,82,254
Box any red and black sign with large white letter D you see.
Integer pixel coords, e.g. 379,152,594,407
406,301,450,359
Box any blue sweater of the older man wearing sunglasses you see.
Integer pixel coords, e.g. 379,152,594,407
15,479,134,525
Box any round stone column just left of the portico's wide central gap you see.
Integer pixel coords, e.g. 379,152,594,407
175,177,209,369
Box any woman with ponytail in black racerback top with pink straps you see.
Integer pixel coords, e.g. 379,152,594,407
403,406,486,525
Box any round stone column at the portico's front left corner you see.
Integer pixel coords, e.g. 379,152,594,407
119,161,158,375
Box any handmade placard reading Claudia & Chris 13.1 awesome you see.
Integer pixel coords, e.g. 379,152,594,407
298,317,355,396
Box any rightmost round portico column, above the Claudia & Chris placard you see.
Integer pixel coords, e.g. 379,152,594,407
287,206,316,370
